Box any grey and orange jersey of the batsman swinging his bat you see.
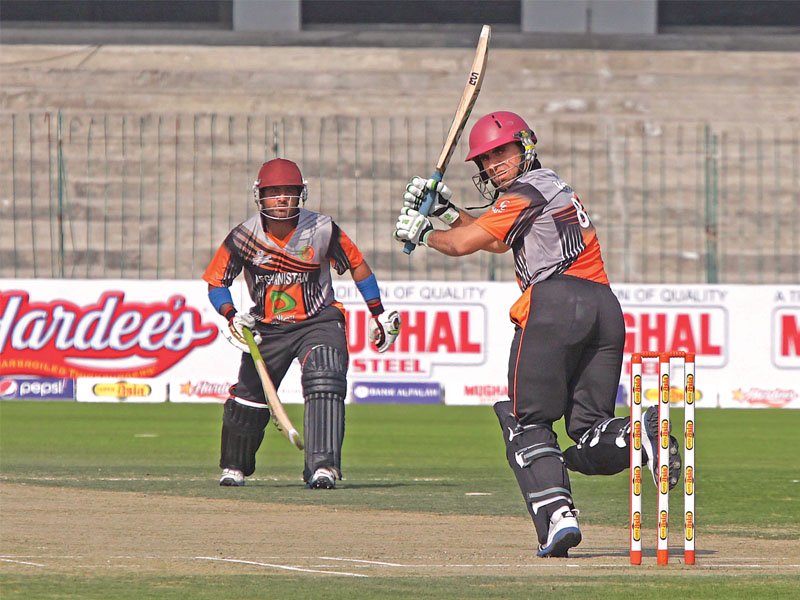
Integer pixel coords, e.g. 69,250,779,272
476,169,608,326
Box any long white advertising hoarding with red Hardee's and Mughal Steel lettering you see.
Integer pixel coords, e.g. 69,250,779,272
0,277,800,408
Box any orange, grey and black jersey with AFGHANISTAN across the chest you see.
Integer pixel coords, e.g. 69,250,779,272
203,208,364,323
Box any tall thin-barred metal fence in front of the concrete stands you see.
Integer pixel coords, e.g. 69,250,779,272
0,113,800,283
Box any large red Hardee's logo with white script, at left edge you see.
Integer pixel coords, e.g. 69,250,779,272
0,290,218,377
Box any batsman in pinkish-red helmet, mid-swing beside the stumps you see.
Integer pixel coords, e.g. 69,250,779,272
394,111,681,557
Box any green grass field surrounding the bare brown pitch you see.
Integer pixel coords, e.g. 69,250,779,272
0,402,800,599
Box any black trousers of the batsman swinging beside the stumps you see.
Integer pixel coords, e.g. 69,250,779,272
508,275,625,441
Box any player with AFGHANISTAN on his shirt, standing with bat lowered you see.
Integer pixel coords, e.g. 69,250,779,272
203,158,400,489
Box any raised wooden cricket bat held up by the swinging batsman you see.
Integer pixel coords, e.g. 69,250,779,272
403,25,492,254
